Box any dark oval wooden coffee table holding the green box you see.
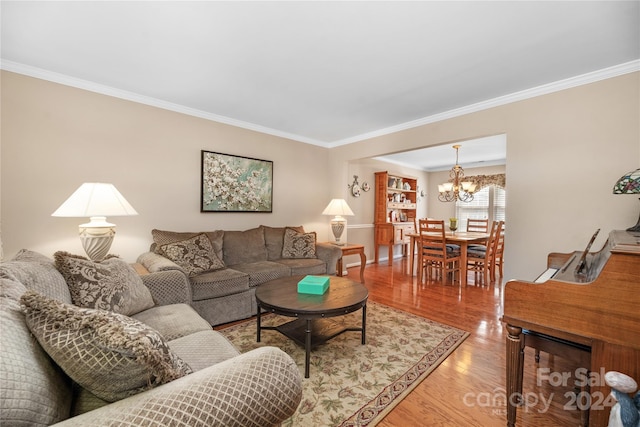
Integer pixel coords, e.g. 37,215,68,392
256,276,369,378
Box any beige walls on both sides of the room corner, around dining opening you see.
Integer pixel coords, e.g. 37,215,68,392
0,72,640,284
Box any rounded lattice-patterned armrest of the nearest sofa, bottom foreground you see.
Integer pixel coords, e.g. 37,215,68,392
55,347,302,427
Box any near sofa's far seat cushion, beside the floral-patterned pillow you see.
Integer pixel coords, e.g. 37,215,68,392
131,304,211,341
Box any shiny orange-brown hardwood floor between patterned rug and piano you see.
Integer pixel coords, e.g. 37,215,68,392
348,258,581,427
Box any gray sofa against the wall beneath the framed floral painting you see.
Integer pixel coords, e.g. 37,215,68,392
138,225,342,325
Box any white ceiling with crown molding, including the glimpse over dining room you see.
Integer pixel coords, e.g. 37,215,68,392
0,1,640,169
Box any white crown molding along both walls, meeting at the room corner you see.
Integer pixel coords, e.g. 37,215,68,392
0,59,640,148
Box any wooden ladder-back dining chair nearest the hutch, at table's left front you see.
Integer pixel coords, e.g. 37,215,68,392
418,219,462,284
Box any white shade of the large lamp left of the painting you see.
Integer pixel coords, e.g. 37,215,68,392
51,182,138,217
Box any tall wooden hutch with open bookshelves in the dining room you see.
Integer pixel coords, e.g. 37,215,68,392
374,171,418,264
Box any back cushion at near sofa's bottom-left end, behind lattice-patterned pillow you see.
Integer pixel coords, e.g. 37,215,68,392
0,280,72,426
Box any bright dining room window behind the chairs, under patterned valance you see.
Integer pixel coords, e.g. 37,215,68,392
456,185,506,230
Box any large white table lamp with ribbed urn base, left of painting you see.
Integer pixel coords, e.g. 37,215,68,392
51,182,138,261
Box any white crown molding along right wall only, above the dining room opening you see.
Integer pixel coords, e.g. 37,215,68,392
329,60,640,148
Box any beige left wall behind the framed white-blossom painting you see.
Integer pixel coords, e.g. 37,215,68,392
1,71,338,261
